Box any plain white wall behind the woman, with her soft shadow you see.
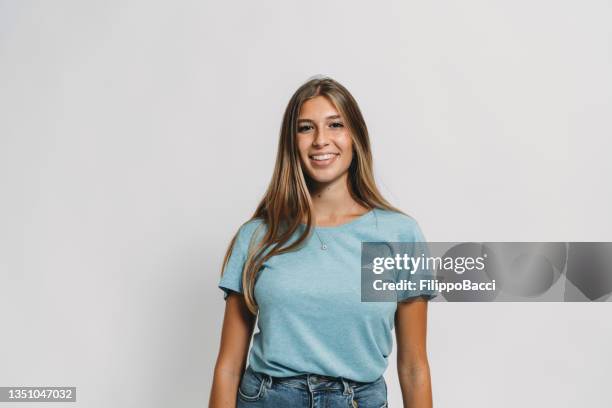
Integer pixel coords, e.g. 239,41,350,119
0,0,612,408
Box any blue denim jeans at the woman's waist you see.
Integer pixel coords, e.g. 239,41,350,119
237,366,388,408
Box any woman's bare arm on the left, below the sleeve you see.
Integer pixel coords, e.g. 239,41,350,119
208,293,256,408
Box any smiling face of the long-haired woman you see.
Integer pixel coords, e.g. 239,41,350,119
297,96,353,183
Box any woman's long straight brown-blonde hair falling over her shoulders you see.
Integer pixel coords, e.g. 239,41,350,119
222,77,403,314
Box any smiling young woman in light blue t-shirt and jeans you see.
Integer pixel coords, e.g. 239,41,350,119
210,77,436,408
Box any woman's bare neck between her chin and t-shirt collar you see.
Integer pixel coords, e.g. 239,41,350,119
310,174,368,226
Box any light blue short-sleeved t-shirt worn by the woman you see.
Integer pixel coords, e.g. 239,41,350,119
218,209,437,382
